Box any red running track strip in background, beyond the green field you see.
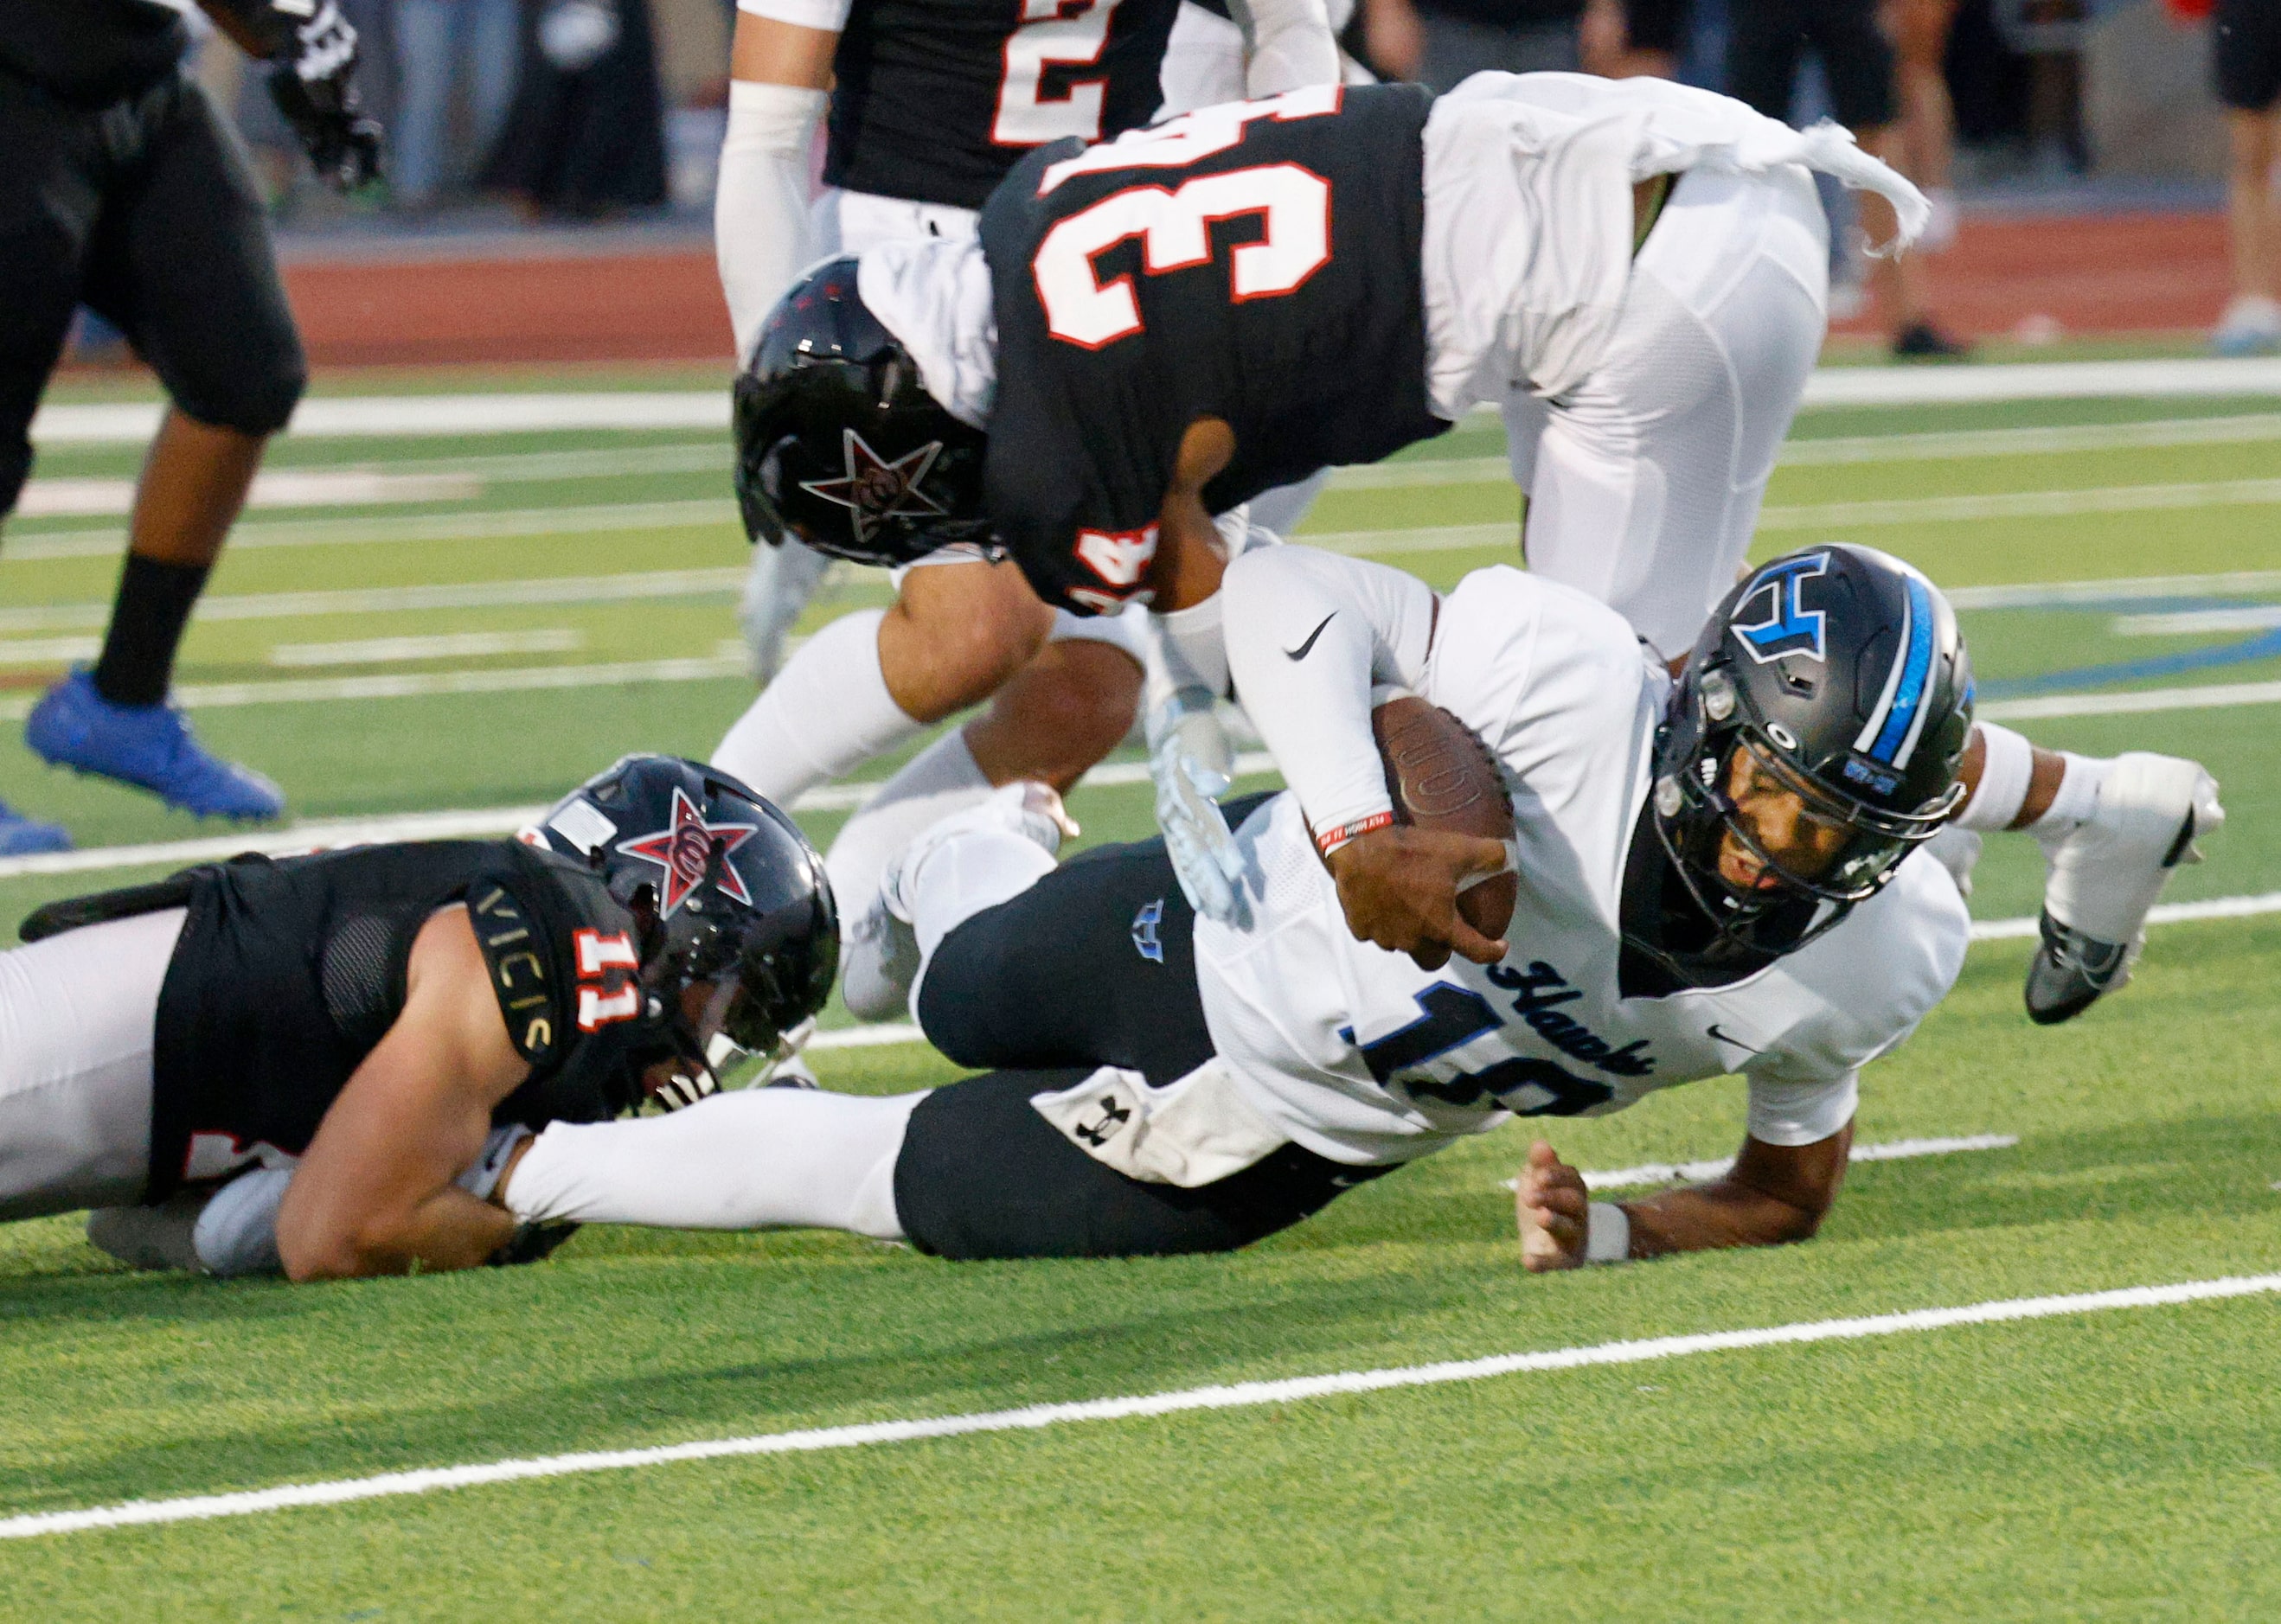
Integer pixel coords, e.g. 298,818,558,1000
271,214,2227,365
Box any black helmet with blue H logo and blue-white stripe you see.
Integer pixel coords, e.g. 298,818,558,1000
1651,543,1973,971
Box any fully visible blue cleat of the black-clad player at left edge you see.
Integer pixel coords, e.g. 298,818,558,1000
22,666,285,819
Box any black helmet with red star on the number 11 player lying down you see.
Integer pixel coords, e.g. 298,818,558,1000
538,755,839,1104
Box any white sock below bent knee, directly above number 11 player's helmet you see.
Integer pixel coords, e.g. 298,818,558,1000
712,609,926,808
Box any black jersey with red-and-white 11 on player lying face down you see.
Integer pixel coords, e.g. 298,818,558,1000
92,840,645,1202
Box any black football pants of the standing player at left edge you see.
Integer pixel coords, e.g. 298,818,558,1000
0,68,308,515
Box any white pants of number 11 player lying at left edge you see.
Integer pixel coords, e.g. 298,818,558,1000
0,908,185,1220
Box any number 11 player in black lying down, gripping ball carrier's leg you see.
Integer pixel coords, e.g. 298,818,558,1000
0,755,839,1280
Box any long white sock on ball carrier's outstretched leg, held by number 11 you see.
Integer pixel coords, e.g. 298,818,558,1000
506,1088,926,1241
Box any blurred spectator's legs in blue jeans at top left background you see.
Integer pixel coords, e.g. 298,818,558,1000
388,0,522,214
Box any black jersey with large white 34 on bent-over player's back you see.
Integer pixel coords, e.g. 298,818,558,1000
981,85,1448,614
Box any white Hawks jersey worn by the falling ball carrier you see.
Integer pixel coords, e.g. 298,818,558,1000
1195,568,1969,1163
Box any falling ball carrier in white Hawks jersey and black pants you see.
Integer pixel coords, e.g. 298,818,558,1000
504,545,1970,1269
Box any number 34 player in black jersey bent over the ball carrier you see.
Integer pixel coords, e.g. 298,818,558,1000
739,73,2220,1020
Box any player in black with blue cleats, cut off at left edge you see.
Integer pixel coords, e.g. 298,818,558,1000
0,0,381,853
